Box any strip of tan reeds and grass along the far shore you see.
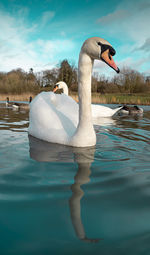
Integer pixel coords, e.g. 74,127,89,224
0,93,150,105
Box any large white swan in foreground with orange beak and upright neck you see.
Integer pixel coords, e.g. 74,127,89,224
28,37,119,147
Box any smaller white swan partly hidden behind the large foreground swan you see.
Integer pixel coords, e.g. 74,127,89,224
53,81,123,118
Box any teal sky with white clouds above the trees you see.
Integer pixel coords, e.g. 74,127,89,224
0,0,150,76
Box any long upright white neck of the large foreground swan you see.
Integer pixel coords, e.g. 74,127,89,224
69,50,96,147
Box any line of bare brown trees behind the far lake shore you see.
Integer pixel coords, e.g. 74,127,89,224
0,59,150,94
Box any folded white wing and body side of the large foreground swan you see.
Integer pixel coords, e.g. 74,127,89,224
29,92,76,144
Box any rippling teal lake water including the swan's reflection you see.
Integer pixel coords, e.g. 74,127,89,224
0,104,150,255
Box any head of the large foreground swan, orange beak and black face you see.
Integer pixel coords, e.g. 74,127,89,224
82,37,120,73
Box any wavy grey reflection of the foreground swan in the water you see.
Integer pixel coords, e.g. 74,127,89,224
29,135,101,243
